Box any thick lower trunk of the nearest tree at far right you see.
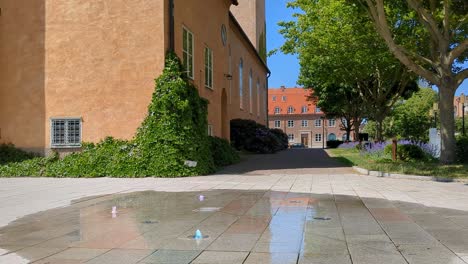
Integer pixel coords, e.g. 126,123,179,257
439,77,456,164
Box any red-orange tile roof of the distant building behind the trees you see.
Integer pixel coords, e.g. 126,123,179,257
268,88,317,115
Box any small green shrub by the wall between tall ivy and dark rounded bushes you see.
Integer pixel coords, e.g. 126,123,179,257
210,137,240,167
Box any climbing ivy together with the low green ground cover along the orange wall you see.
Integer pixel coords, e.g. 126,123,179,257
0,53,216,177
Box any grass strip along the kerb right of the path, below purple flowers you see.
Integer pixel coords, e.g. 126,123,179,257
327,149,468,178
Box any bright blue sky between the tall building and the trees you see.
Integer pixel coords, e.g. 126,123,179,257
266,0,468,95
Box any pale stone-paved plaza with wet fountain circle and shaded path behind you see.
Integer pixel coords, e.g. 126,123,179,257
0,150,468,264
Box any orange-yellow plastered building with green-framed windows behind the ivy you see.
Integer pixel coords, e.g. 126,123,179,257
0,0,269,154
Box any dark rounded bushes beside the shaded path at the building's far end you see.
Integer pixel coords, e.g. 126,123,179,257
231,119,287,154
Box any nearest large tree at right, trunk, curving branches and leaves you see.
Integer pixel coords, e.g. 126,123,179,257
354,0,468,163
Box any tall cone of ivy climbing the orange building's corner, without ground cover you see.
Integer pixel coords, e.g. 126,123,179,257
135,51,215,177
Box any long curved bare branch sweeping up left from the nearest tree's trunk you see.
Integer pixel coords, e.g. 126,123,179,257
361,0,441,86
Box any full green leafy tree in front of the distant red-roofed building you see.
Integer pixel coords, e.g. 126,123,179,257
280,0,418,140
